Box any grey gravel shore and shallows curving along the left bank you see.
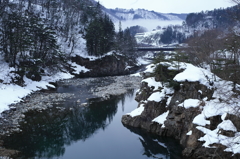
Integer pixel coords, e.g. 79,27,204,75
0,76,142,158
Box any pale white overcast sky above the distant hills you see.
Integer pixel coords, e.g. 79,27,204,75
96,0,235,13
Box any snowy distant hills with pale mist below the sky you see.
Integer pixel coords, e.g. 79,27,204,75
99,6,187,31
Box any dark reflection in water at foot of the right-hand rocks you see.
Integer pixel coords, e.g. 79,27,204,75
124,127,182,159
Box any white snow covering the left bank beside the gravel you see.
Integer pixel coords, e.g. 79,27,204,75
0,61,73,113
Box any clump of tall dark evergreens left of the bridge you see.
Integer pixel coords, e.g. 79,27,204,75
85,9,137,58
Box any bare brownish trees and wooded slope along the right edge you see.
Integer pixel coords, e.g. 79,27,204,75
179,1,240,91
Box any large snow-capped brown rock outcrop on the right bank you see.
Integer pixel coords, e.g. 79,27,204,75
122,63,240,159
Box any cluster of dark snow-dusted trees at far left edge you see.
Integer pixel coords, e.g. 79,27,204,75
0,6,65,80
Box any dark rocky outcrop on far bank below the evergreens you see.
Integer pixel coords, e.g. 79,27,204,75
72,54,139,77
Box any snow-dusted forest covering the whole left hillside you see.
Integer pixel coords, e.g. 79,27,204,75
0,0,137,85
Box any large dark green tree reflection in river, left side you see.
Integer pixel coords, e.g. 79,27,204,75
2,96,130,158
